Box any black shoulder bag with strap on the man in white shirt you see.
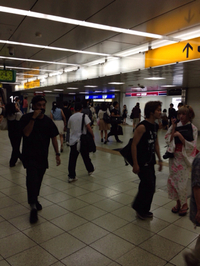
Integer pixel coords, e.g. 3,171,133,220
80,114,96,152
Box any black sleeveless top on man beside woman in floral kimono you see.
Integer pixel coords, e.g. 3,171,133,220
137,120,158,166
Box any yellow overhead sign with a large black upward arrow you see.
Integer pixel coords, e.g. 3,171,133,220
145,38,200,68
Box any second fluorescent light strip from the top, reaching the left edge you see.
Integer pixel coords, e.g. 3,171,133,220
0,40,110,56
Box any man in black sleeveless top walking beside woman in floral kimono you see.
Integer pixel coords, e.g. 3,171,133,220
131,101,162,220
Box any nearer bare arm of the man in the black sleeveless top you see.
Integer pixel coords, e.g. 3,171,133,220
131,125,146,174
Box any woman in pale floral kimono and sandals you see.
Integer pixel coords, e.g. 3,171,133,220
165,105,198,216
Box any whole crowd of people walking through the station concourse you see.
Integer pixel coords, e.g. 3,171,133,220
1,96,200,265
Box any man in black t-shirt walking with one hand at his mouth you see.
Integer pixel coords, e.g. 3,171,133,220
20,95,60,223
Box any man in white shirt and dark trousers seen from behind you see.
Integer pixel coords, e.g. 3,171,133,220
68,103,94,183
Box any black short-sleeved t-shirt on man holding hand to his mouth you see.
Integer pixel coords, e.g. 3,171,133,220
20,113,59,168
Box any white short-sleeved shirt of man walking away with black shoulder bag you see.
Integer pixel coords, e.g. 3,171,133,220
68,112,91,146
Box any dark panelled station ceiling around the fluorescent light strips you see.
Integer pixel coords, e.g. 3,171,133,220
0,0,200,94
